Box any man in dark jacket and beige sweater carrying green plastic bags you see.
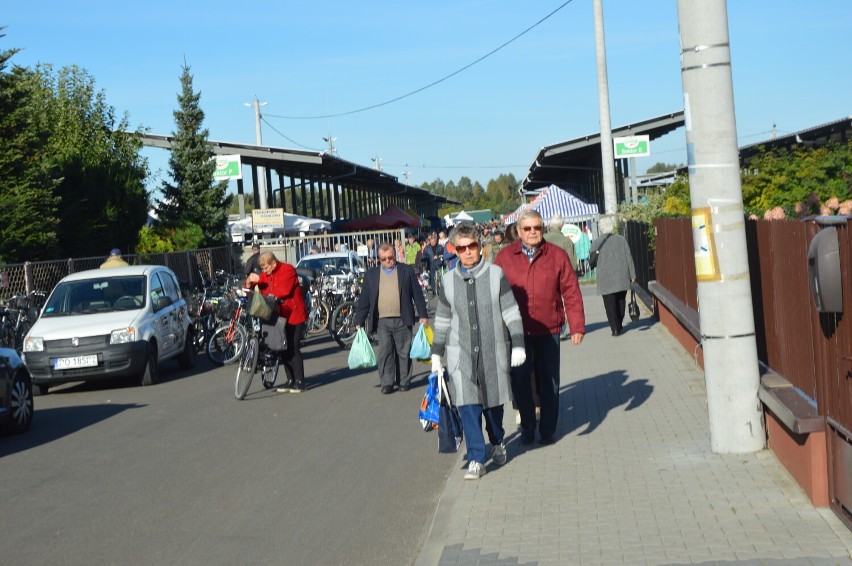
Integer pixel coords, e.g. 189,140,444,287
355,242,429,394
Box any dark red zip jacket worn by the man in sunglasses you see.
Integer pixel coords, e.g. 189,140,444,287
494,241,586,336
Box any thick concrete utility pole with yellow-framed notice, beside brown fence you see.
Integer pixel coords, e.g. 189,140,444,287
677,0,766,454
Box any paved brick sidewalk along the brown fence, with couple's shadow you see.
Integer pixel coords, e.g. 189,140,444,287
416,286,852,565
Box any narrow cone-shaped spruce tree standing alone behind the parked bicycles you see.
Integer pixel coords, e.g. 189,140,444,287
157,64,231,246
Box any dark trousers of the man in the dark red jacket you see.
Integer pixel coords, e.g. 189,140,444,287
511,334,560,439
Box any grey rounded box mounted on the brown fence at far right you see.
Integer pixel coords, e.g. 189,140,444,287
808,226,843,312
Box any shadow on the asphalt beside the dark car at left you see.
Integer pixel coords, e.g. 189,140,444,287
0,403,146,458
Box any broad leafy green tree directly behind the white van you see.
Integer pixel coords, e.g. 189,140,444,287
36,65,149,257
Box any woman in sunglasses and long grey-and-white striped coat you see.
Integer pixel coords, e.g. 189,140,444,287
432,223,526,480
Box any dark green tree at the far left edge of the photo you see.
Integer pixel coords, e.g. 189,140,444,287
0,36,59,263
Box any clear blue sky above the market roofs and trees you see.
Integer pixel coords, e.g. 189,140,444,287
0,0,852,195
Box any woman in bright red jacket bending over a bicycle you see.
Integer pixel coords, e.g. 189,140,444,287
246,252,307,393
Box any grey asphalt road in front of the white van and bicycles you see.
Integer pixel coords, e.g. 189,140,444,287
0,334,460,565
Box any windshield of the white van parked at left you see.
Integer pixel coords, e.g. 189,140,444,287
41,275,148,317
